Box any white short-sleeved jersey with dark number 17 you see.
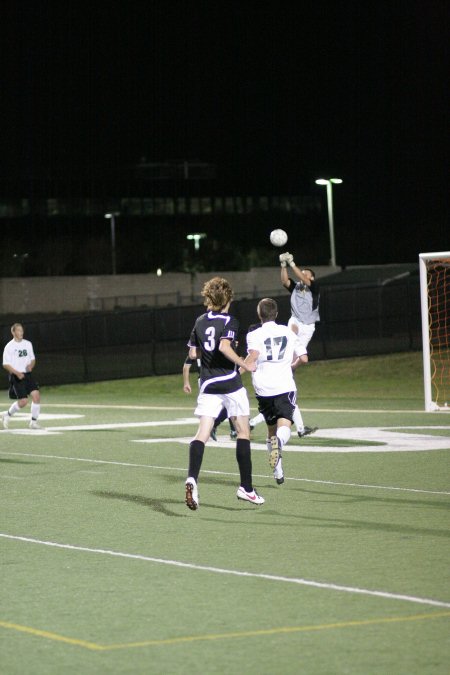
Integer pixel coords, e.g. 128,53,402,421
247,321,297,396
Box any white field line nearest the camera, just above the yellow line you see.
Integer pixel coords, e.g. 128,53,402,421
0,533,450,607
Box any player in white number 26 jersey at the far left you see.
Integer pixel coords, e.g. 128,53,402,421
1,323,41,429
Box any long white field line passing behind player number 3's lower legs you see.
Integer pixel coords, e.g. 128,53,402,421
0,446,450,495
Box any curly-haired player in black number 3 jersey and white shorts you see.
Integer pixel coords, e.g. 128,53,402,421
186,277,264,511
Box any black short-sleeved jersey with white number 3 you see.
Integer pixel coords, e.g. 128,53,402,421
188,310,243,394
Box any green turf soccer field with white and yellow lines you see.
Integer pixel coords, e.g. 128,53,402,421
0,353,450,675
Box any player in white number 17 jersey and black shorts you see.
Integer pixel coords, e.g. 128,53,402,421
245,298,300,485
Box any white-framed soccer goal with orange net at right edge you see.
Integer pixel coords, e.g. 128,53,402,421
419,251,450,412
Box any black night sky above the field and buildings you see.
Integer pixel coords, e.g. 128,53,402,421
0,0,450,264
